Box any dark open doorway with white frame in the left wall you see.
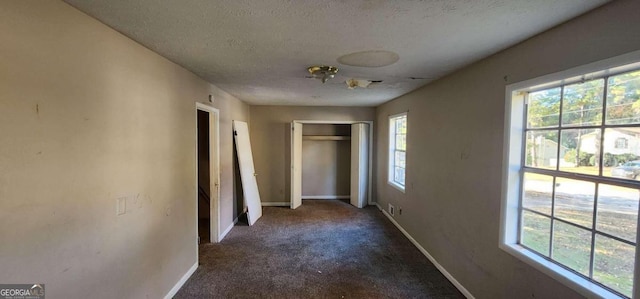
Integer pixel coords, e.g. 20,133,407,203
196,103,220,244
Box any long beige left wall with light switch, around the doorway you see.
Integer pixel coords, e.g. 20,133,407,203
0,1,249,298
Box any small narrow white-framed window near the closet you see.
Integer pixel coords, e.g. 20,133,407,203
389,113,407,191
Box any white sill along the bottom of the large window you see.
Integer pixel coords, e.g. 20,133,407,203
500,244,625,299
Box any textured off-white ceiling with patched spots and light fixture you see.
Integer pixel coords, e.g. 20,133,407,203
66,0,608,106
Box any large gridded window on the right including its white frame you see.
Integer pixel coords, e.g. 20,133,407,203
500,54,640,298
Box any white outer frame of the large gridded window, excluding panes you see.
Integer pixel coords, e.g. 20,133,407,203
498,51,640,299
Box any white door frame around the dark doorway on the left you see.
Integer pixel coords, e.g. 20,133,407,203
195,103,222,243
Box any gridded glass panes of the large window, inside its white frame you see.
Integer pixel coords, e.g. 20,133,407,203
518,70,640,296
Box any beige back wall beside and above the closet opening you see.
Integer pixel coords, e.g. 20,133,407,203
250,106,375,202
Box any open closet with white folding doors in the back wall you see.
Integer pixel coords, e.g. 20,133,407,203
291,120,373,209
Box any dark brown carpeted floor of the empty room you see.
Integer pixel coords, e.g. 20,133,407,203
175,200,464,298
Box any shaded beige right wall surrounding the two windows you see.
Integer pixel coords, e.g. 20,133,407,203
376,0,640,298
